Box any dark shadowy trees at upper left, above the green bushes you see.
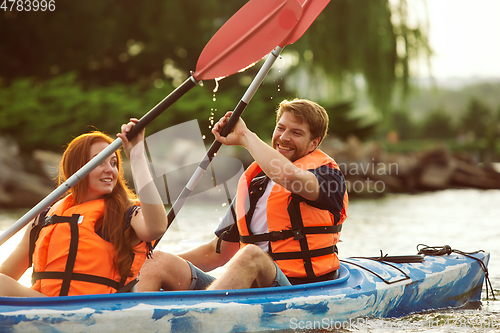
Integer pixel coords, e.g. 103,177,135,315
0,0,245,85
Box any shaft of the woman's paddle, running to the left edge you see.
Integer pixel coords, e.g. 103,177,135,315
0,76,197,245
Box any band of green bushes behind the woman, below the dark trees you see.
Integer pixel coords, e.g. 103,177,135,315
0,73,292,152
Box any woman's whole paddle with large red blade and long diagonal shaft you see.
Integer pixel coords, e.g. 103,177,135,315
0,0,302,245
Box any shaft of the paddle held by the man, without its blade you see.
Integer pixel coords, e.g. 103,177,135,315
162,46,283,235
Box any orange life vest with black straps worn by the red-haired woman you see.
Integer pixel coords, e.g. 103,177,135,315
30,194,148,296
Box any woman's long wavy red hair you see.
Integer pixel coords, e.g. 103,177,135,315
59,131,138,278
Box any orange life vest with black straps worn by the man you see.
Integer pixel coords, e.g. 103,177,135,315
236,150,348,278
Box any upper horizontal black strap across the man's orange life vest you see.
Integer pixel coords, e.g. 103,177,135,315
240,224,342,244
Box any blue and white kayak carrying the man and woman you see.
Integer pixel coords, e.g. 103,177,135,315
0,251,489,333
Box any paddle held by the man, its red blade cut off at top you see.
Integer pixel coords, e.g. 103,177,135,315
160,0,330,240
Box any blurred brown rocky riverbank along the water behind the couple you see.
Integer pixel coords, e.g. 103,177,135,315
0,137,500,209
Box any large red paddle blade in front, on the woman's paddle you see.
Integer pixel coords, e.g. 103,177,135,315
193,0,303,81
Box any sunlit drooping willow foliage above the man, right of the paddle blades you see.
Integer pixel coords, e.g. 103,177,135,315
282,0,431,116
